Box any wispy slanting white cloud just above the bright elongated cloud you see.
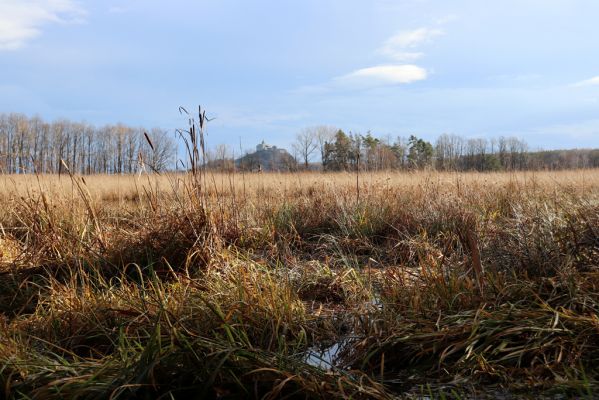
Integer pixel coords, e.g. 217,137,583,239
378,28,444,62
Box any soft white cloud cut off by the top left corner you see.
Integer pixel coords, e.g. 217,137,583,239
0,0,85,51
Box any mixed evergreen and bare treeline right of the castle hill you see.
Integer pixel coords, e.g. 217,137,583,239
293,126,599,171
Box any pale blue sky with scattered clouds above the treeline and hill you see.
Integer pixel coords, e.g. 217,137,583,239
0,0,599,151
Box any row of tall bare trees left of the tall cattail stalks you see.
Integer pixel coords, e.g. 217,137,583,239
0,114,176,174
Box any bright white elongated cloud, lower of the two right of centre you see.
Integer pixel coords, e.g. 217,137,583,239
334,65,427,88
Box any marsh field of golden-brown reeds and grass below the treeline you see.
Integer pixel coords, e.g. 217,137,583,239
0,170,599,399
